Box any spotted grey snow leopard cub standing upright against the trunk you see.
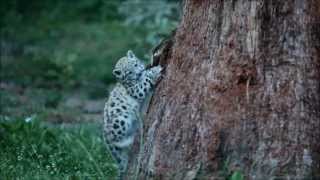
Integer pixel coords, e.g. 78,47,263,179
103,50,162,177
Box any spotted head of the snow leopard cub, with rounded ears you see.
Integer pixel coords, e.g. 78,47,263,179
112,50,145,81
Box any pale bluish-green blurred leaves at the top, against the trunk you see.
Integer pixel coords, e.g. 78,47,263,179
119,0,180,49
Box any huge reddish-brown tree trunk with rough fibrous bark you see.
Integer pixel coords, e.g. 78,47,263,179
126,0,320,180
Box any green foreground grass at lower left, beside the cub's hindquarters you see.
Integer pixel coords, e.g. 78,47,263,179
0,117,116,179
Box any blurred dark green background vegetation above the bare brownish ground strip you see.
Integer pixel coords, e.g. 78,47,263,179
0,0,178,97
